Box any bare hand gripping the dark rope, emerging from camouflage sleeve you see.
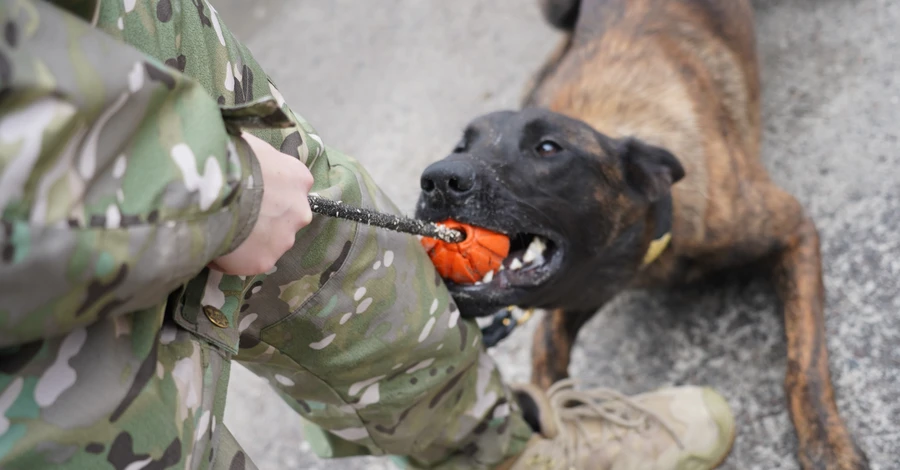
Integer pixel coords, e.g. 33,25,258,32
209,133,313,276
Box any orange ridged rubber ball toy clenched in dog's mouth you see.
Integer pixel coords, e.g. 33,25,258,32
422,219,509,284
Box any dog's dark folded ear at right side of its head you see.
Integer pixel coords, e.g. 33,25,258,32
618,138,684,202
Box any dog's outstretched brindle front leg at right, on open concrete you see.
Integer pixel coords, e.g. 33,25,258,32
775,213,869,470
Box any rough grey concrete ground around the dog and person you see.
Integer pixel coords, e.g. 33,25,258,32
214,0,900,470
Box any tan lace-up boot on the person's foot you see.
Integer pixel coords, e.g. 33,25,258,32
499,380,735,470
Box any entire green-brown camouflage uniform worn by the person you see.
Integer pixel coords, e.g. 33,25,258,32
0,0,531,470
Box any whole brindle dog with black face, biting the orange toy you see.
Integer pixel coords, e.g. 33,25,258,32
416,0,868,470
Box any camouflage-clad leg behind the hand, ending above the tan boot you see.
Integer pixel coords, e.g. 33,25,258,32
85,0,531,468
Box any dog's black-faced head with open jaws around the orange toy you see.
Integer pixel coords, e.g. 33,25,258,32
416,109,684,317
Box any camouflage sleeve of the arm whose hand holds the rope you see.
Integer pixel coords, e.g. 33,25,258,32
0,0,262,348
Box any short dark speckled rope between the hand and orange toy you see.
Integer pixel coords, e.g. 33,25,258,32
309,194,465,243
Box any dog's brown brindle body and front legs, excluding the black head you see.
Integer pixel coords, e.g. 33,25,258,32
525,0,868,469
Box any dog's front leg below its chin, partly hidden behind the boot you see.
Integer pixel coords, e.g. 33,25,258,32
531,309,597,390
